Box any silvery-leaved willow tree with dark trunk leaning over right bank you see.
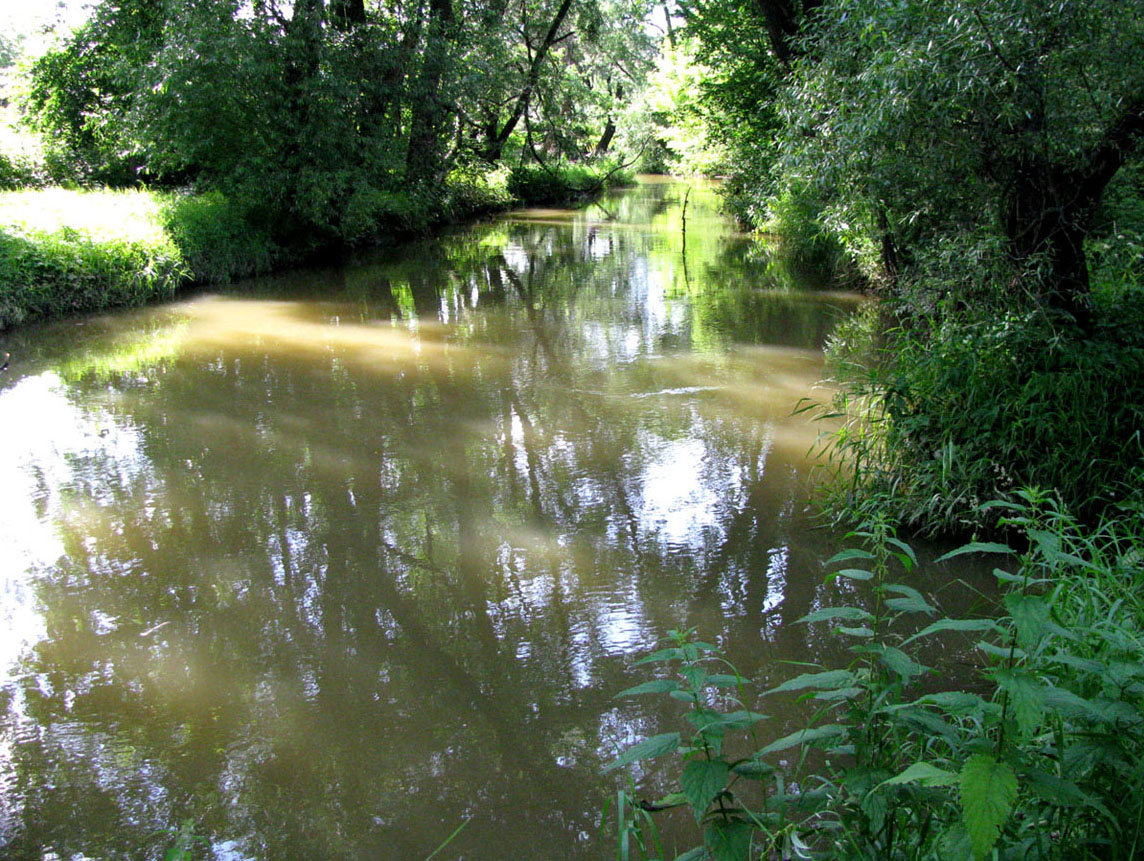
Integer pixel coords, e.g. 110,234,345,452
781,0,1144,322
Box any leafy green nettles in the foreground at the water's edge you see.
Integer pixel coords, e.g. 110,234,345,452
606,492,1144,861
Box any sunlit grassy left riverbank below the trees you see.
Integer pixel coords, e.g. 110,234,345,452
0,166,630,330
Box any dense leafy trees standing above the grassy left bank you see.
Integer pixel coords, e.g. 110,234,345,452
15,0,652,248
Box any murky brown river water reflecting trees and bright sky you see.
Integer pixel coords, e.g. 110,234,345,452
0,180,938,859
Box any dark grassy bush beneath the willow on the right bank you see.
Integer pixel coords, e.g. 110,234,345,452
809,290,1144,532
